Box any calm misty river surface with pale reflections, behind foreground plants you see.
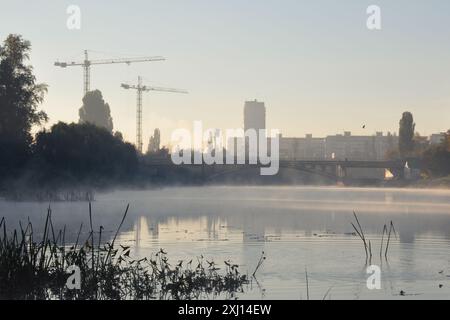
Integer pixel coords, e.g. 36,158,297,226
0,187,450,300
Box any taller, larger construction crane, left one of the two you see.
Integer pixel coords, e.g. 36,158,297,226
55,50,166,97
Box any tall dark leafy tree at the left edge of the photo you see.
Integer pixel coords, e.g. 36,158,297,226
0,34,48,177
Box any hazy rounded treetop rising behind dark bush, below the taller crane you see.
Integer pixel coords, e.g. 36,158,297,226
79,90,113,133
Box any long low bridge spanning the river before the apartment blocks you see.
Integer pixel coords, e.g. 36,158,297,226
144,157,407,182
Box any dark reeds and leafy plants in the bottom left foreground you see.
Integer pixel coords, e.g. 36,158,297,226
0,208,250,300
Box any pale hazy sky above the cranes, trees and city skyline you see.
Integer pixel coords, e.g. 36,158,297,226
0,0,450,146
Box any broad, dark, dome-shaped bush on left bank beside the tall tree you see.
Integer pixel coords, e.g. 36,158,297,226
33,122,138,184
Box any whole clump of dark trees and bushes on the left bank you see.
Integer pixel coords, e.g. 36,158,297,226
0,35,138,188
